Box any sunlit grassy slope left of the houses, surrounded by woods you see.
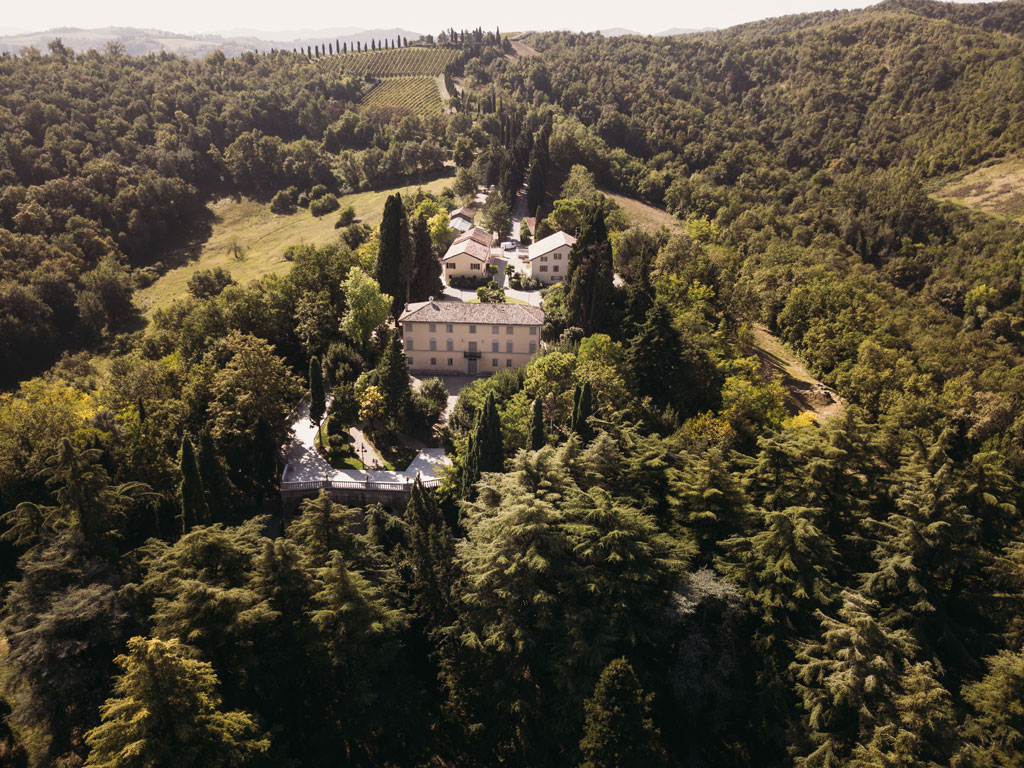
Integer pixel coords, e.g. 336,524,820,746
135,178,452,314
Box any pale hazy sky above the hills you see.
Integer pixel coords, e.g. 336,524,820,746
0,0,983,33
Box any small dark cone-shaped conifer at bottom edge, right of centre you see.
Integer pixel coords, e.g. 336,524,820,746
580,658,668,768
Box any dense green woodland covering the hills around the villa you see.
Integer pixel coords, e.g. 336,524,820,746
0,0,1024,768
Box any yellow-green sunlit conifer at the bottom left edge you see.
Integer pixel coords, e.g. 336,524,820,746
85,637,269,768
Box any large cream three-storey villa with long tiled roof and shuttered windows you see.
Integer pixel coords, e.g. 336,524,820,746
398,300,544,374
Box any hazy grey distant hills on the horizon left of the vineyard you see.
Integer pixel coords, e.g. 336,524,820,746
0,27,420,58
